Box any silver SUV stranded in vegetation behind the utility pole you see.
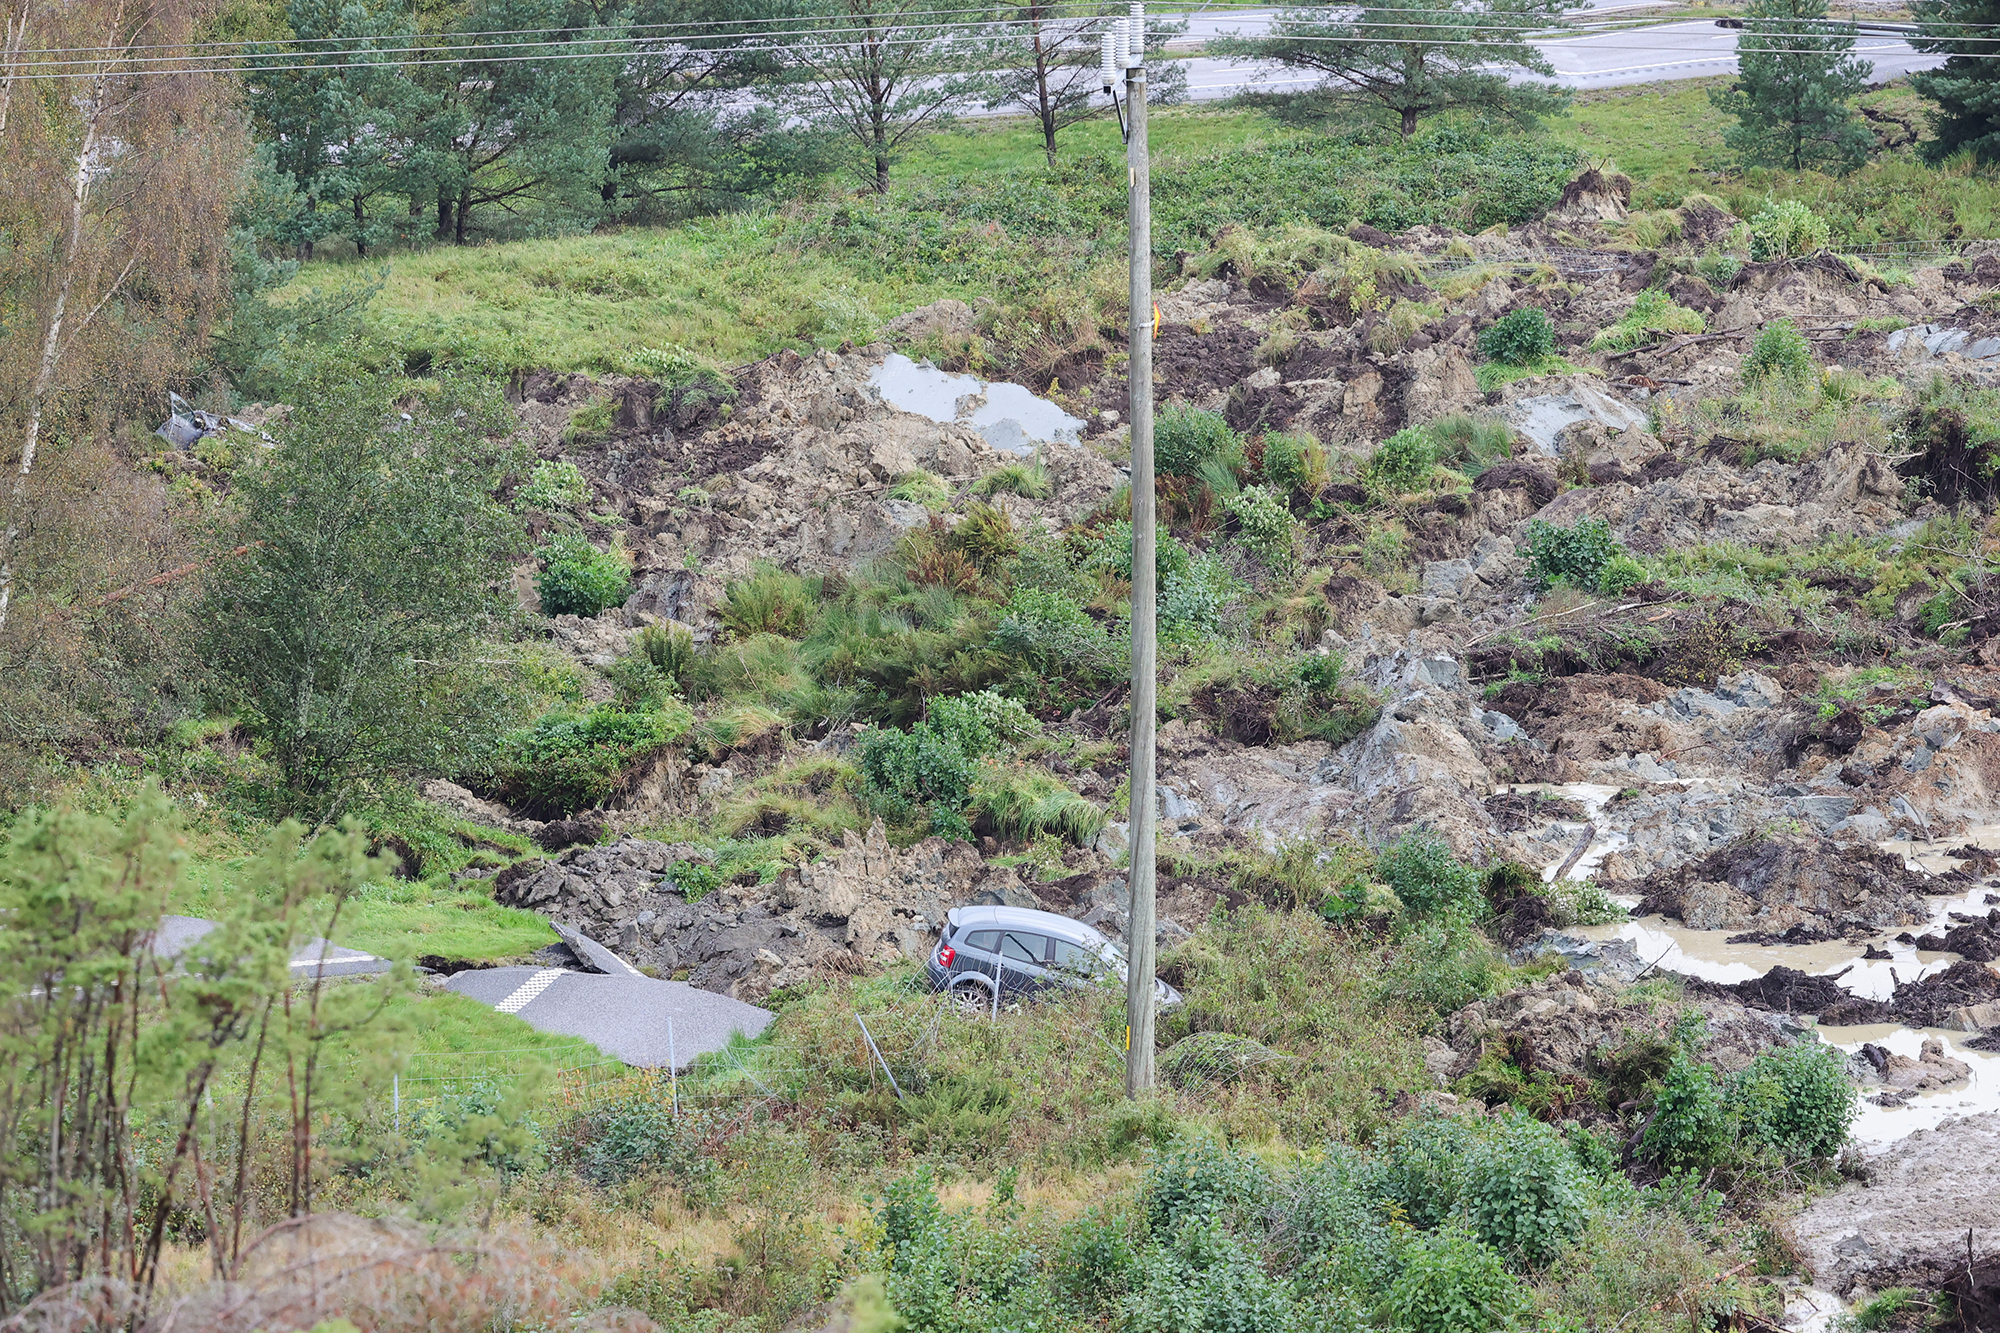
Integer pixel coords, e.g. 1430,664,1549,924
926,907,1180,1009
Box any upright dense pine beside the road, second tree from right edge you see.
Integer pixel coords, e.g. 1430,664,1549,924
1708,0,1874,172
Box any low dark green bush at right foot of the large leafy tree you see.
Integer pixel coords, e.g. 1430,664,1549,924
492,703,694,819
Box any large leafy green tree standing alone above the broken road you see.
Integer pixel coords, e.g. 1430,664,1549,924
202,360,526,821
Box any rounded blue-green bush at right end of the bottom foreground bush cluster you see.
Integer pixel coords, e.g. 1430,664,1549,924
1460,1115,1584,1269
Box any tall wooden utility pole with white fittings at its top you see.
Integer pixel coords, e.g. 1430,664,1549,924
1106,4,1158,1097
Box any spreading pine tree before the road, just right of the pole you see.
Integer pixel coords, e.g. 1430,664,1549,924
1208,0,1568,138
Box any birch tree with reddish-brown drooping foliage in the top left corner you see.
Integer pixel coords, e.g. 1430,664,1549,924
0,0,244,632
